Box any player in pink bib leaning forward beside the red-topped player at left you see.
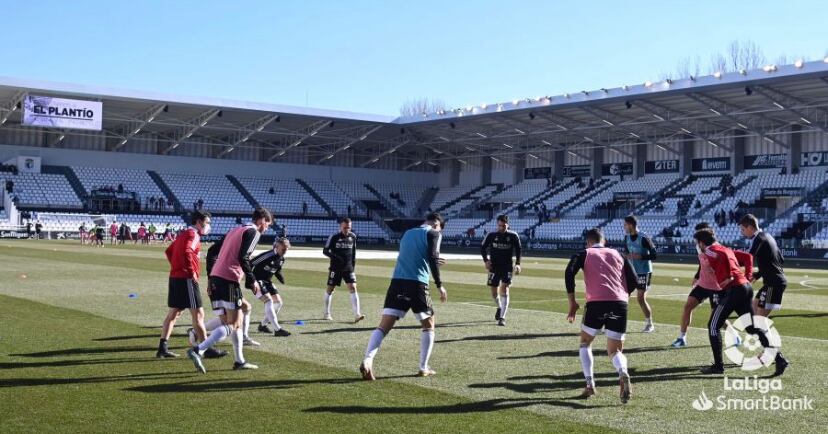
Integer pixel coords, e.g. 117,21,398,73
187,208,273,373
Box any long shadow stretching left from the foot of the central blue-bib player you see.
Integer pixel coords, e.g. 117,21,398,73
124,377,363,393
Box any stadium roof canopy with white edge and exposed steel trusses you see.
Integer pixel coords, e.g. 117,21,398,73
0,58,828,170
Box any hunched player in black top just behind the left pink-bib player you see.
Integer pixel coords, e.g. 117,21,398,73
251,238,290,336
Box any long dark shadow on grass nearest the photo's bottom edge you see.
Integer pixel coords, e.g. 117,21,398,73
302,398,609,415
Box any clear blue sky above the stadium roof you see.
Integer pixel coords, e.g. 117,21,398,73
0,0,828,115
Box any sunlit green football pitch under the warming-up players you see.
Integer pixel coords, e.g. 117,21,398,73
0,240,828,433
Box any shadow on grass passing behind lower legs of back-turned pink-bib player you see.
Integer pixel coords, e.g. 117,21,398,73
468,366,711,394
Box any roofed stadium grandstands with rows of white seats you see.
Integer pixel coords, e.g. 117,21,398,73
0,61,828,253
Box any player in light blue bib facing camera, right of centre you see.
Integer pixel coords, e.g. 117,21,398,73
624,215,656,333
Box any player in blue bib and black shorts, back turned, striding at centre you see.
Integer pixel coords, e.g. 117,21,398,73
359,213,447,381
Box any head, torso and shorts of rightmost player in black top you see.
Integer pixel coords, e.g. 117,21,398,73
739,214,788,317
